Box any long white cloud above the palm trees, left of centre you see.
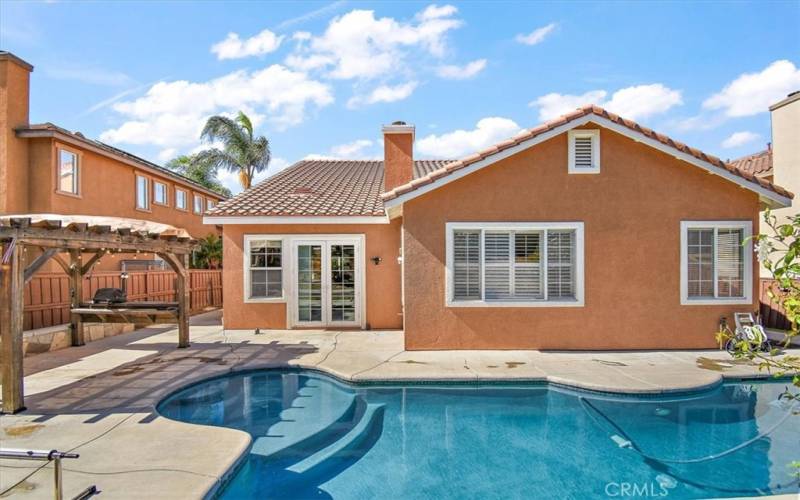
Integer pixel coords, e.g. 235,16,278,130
100,64,333,149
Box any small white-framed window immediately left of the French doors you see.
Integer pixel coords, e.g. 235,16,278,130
245,237,283,301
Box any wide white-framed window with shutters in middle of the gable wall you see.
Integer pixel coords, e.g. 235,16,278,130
446,222,583,307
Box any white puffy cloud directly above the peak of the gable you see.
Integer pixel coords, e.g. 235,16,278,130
529,83,683,121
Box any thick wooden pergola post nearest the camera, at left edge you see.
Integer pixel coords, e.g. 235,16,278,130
0,242,25,413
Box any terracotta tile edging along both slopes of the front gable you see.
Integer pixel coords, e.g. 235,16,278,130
381,105,794,201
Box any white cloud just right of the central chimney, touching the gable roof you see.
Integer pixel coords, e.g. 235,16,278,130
415,116,522,158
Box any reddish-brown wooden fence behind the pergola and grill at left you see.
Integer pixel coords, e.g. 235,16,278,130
23,269,222,330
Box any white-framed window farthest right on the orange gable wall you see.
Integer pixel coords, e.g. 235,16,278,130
681,221,753,305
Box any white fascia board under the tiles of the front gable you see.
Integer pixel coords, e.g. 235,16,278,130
385,114,792,210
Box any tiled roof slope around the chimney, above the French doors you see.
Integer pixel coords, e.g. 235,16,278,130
207,160,453,217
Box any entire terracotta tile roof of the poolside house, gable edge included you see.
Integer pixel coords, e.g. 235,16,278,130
207,106,793,217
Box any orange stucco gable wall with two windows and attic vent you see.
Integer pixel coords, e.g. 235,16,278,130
404,124,759,349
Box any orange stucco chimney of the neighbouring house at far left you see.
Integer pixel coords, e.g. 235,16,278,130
0,51,33,214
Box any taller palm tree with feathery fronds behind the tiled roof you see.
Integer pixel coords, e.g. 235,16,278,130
197,111,270,189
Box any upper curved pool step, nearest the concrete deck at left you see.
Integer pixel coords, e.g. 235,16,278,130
250,378,364,459
